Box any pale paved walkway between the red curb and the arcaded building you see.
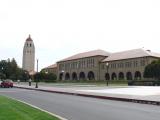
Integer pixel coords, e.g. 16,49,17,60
14,83,160,105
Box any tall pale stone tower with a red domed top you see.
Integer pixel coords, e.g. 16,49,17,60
22,35,35,72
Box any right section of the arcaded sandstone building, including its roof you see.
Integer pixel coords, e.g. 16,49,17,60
101,49,160,80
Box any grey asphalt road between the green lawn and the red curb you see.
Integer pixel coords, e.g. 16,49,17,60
0,88,160,120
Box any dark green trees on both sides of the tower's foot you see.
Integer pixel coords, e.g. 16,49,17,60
0,58,56,82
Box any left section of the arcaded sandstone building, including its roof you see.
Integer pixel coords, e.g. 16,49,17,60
57,50,110,80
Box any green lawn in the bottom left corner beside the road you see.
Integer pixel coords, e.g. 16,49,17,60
0,96,59,120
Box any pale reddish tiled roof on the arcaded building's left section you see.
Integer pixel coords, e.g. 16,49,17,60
58,50,110,62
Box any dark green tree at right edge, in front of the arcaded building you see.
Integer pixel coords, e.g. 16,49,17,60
144,60,160,80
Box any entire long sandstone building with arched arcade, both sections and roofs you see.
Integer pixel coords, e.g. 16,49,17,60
43,49,160,80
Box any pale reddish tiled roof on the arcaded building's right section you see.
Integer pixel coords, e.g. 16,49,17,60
102,49,160,62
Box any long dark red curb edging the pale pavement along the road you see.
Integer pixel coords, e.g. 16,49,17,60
14,86,160,106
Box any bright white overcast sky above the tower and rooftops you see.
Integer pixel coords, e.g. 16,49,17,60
0,0,160,69
